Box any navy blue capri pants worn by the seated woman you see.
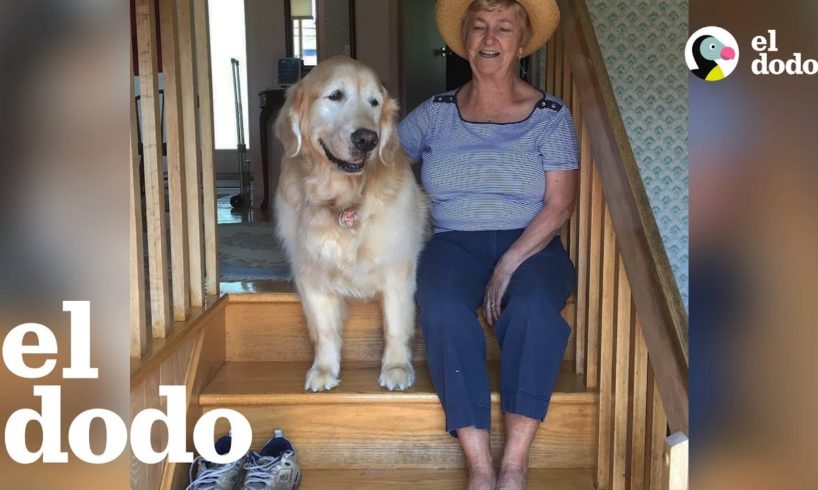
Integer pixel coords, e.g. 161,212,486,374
416,230,575,435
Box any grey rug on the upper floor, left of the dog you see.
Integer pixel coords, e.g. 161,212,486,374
216,222,292,281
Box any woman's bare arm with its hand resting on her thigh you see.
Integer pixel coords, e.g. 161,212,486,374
483,170,578,325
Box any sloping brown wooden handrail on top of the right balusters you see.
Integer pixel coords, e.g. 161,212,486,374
557,0,688,433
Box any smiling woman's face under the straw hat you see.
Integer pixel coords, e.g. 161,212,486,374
466,9,523,75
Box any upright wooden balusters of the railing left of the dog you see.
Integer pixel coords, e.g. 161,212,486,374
130,0,219,359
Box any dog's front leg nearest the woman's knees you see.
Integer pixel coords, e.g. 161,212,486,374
378,264,415,390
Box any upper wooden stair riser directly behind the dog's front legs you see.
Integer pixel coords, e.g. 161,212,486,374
225,302,575,362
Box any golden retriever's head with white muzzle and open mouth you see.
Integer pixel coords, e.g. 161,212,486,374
276,56,398,175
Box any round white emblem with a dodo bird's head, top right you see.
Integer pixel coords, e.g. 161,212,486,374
685,26,738,82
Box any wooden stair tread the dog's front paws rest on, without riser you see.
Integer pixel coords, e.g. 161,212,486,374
199,361,596,406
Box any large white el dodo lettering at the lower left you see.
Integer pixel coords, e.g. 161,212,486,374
3,301,253,464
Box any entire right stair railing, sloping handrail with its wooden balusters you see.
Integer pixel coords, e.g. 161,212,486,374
534,0,688,489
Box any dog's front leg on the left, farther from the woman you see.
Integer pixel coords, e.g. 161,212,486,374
299,288,346,391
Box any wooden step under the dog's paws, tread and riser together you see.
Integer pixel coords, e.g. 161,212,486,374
199,361,597,469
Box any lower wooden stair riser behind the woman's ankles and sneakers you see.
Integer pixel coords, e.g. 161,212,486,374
207,399,597,470
